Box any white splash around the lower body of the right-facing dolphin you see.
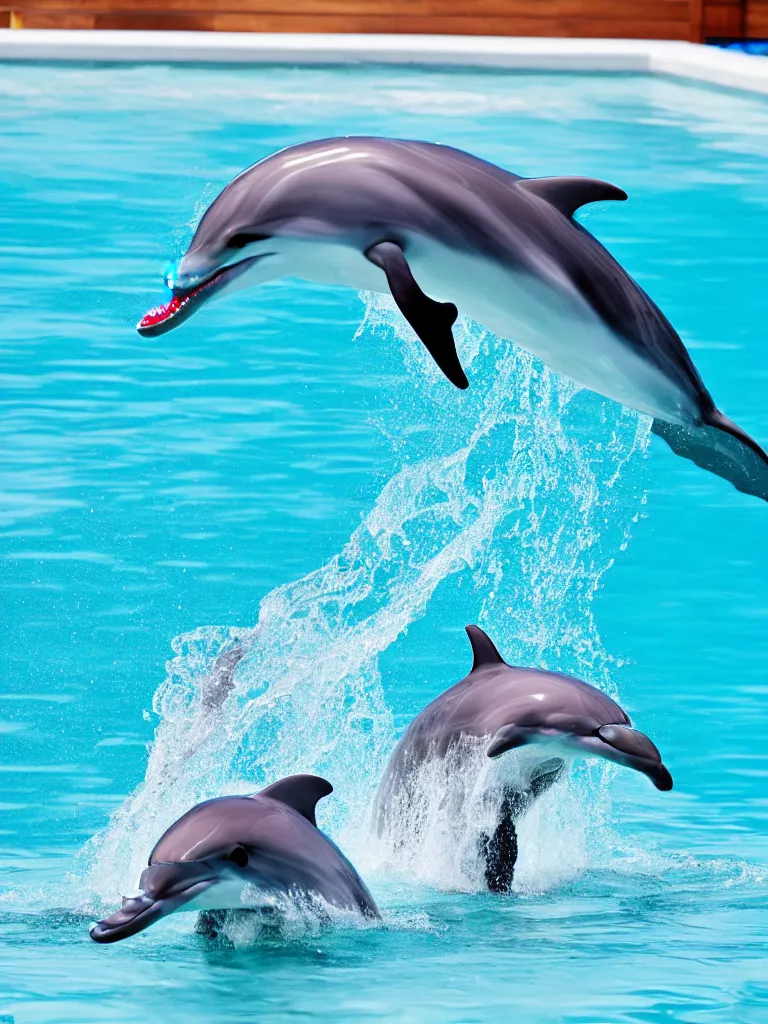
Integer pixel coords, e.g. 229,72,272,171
369,737,593,893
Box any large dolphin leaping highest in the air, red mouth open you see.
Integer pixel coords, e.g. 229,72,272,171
138,137,768,501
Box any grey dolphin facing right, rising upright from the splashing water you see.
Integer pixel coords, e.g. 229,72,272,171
376,626,672,892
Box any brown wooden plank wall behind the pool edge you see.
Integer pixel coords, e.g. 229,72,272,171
0,0,768,42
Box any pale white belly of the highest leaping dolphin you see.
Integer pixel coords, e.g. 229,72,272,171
272,239,695,422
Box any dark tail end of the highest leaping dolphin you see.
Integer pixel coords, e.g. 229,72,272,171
651,409,768,502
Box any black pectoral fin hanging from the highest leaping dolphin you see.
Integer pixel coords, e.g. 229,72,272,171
366,242,469,390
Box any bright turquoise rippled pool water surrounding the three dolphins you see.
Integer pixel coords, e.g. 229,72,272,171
0,65,768,1024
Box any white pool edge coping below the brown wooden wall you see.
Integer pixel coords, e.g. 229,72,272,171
0,29,768,93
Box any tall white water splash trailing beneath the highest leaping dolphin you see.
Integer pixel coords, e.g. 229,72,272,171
77,295,649,899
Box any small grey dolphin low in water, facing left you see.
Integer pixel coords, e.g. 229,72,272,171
90,775,380,942
